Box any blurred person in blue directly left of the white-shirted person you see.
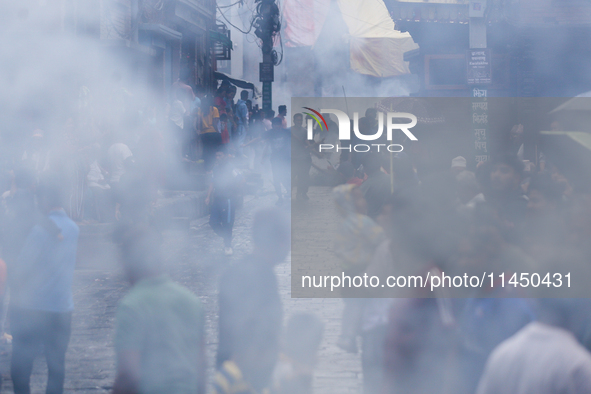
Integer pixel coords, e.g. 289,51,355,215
456,204,537,393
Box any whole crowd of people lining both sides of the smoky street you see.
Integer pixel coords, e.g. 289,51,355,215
0,87,591,394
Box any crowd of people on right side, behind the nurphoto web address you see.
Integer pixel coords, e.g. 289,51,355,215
324,108,591,394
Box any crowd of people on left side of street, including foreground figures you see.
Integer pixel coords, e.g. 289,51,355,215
0,69,322,393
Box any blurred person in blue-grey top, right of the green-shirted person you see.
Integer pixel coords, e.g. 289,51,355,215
214,209,291,394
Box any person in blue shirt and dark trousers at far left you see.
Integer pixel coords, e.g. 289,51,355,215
9,175,79,393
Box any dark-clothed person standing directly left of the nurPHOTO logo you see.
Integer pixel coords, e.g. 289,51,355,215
291,113,312,200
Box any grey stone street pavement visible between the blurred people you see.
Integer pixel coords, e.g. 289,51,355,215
0,187,361,394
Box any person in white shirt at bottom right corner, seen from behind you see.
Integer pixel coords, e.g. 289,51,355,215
477,298,591,394
